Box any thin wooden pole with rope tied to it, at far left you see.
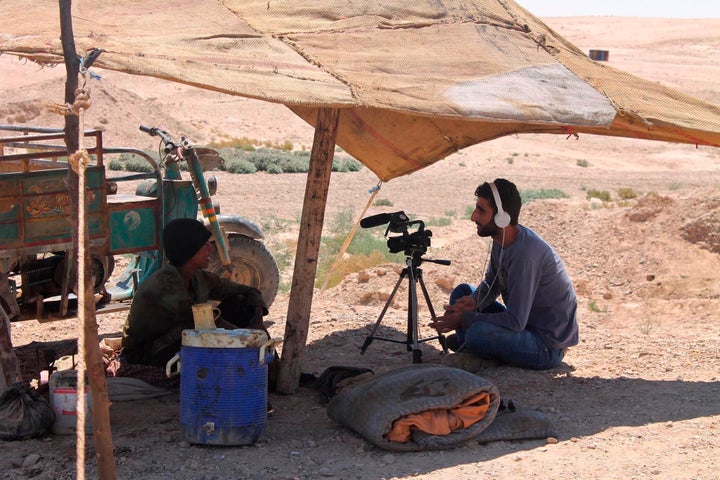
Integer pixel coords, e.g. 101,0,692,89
60,0,117,480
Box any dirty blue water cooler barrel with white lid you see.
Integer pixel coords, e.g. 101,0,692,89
180,329,274,445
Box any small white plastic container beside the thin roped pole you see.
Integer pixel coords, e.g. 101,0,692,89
48,370,92,435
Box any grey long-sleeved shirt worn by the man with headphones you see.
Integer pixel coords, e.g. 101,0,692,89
462,225,578,348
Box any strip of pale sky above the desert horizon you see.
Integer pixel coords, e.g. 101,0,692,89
515,0,720,18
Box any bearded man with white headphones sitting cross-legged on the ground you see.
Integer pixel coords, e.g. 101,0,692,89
430,178,578,370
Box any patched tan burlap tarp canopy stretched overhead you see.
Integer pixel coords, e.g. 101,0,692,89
0,0,720,181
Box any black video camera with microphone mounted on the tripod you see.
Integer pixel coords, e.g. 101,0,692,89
360,211,432,256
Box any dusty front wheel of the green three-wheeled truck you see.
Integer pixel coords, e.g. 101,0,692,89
208,234,280,307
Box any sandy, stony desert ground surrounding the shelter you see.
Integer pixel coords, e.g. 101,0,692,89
0,18,720,480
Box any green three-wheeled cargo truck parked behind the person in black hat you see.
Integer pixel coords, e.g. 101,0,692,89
0,125,279,321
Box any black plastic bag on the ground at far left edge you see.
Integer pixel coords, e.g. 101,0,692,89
0,382,55,440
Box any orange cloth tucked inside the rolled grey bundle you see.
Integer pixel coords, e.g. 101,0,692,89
386,392,490,443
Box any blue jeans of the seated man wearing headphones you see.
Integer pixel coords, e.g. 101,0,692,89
450,283,565,370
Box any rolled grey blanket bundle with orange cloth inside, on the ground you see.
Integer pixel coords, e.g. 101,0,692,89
327,364,500,451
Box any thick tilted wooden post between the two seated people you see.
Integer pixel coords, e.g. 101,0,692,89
277,108,340,394
